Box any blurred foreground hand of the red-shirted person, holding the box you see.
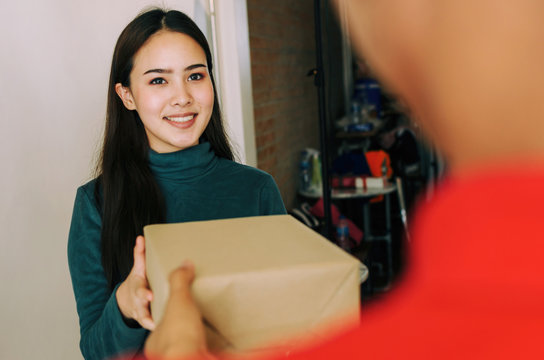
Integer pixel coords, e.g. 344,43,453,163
144,261,215,359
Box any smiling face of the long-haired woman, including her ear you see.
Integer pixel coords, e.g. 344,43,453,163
115,30,214,153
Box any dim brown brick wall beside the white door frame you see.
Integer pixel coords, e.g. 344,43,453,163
247,0,319,209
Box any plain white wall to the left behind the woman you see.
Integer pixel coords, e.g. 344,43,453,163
0,0,254,360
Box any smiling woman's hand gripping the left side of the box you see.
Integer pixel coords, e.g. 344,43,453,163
116,236,155,330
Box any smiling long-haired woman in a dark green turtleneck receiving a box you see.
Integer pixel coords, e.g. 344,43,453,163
68,9,285,359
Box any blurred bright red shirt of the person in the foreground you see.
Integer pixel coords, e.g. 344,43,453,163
131,166,544,360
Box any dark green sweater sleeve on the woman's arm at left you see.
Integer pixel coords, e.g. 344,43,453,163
68,186,148,359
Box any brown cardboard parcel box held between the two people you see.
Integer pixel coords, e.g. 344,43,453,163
144,215,360,352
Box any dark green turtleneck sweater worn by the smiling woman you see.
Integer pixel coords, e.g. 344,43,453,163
68,143,285,359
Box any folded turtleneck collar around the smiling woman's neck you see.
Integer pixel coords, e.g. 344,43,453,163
149,142,217,181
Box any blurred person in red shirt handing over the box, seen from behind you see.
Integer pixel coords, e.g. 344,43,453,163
146,0,544,359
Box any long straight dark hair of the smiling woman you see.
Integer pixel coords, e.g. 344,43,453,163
95,8,234,289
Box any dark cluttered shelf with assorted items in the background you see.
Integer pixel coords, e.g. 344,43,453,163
290,56,438,293
